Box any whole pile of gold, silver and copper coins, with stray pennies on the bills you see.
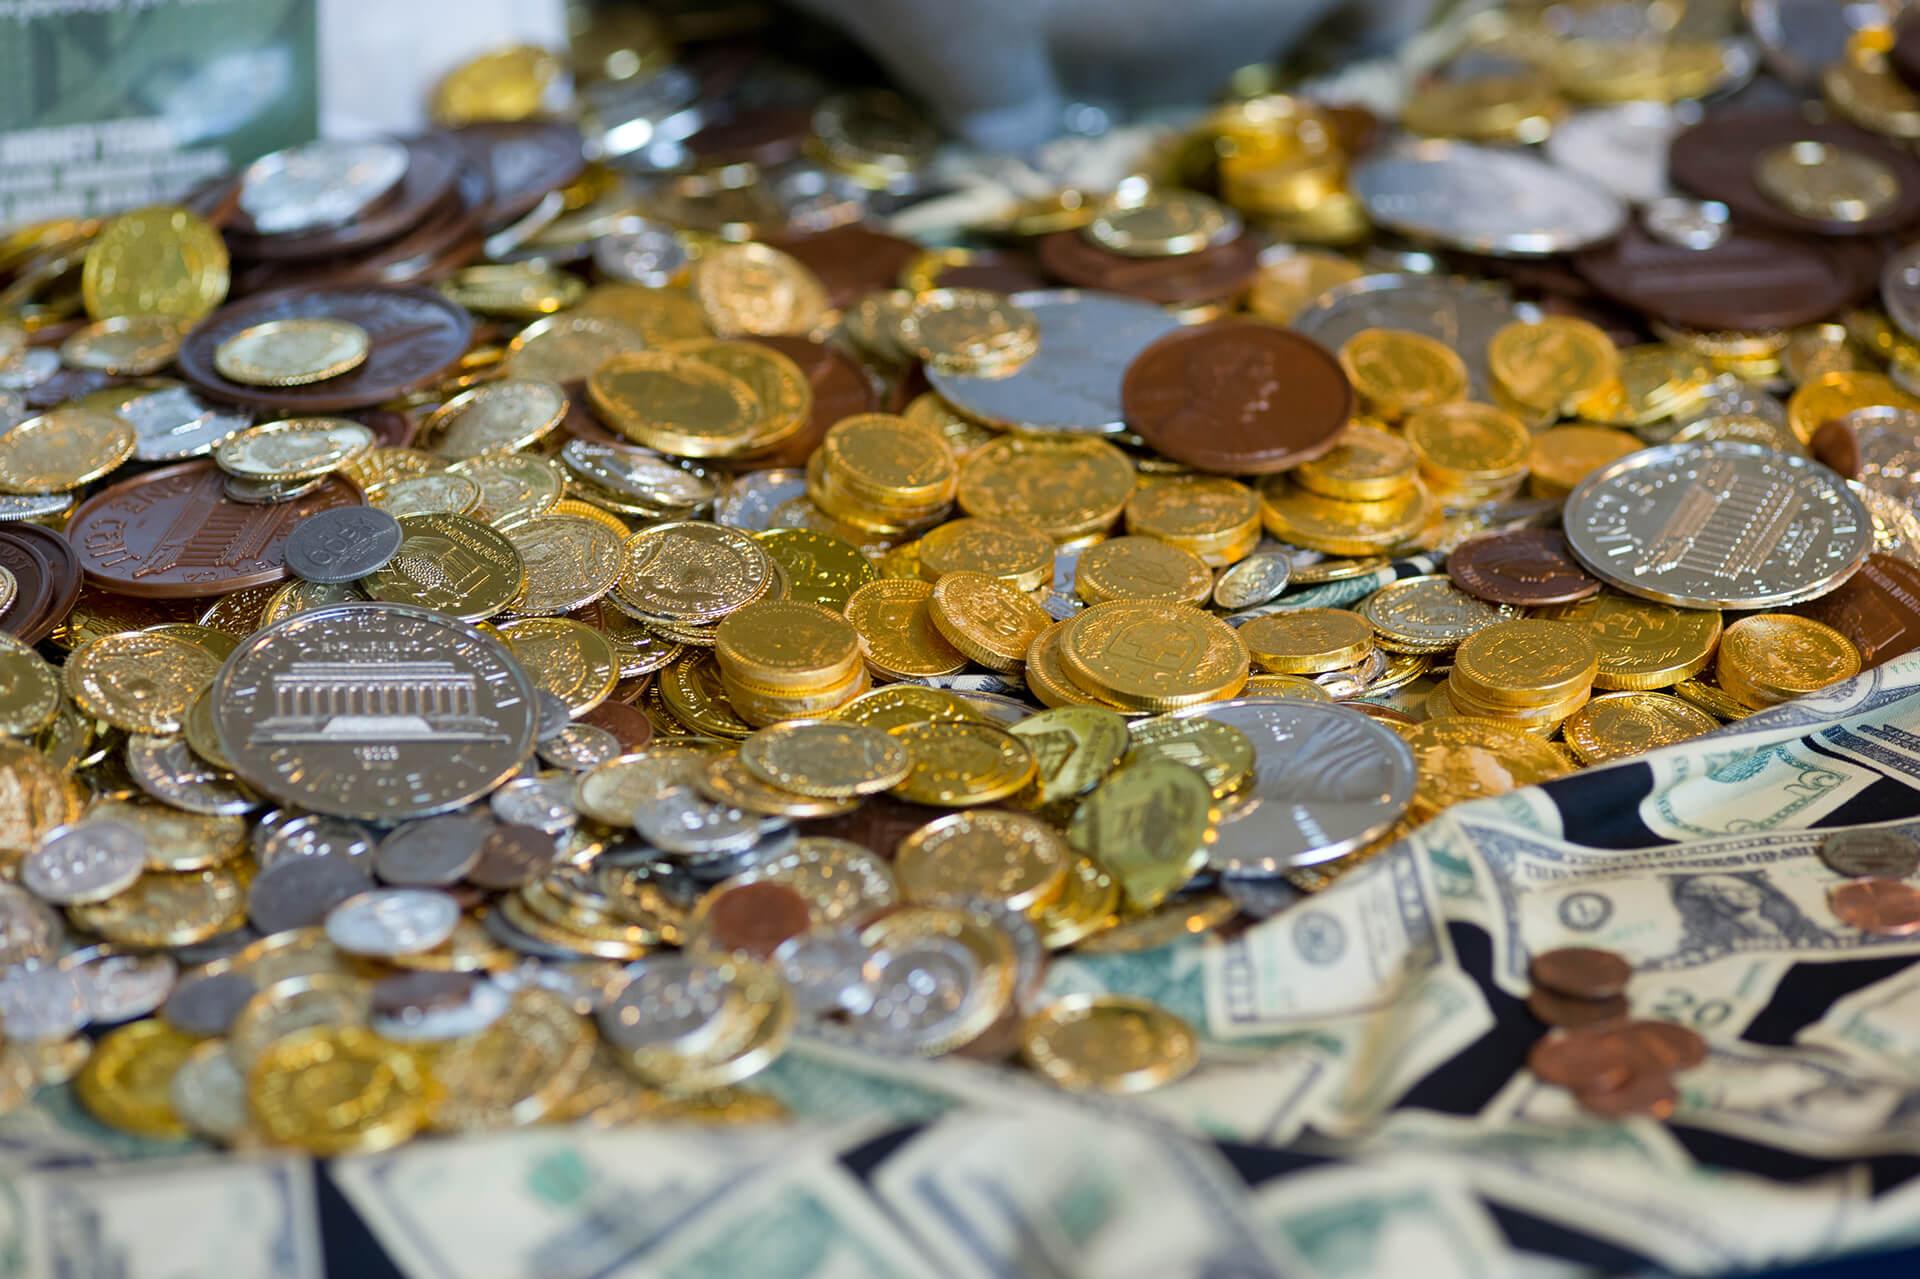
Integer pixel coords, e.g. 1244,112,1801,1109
0,4,1920,1154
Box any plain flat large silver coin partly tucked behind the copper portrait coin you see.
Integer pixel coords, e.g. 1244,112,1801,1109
927,288,1179,436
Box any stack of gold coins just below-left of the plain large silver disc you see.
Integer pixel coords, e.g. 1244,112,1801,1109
806,413,960,538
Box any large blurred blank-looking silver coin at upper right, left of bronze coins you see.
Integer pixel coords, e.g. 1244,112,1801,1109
1350,142,1626,257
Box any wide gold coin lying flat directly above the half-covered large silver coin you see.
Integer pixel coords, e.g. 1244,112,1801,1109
1060,603,1252,711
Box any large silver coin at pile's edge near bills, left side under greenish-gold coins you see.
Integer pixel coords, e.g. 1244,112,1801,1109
1173,697,1413,874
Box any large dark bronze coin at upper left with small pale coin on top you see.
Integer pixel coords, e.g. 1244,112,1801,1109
179,284,474,417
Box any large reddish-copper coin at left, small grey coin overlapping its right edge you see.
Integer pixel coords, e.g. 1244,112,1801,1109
65,461,361,599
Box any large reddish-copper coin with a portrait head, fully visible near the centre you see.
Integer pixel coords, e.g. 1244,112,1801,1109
1121,323,1354,474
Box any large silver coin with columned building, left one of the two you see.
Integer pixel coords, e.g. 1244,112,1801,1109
211,605,536,822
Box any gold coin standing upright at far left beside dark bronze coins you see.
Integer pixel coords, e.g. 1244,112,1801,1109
81,204,228,321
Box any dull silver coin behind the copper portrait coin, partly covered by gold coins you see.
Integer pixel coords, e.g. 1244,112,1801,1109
1292,275,1521,399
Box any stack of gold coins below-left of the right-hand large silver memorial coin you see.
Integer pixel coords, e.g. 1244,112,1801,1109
1427,618,1599,736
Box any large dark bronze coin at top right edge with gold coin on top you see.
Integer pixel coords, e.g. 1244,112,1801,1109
1667,109,1920,236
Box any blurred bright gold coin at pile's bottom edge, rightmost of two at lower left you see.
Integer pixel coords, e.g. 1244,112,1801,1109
248,1022,428,1156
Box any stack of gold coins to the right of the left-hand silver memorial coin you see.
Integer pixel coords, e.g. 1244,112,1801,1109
714,599,872,726
